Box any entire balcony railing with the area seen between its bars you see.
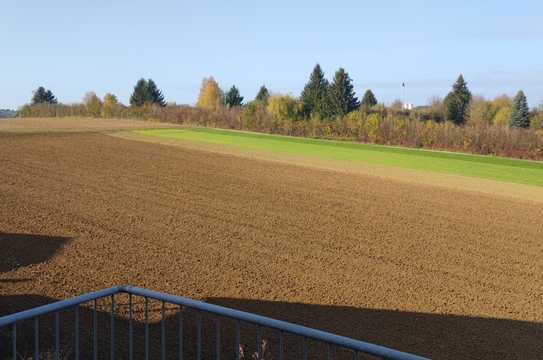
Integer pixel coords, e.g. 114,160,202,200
0,286,430,360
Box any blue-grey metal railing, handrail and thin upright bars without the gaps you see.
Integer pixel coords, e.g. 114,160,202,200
0,285,430,360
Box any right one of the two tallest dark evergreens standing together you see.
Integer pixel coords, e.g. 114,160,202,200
328,68,360,116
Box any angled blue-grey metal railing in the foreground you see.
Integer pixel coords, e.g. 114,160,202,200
0,286,430,360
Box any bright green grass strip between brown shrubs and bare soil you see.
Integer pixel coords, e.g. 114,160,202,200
133,128,543,186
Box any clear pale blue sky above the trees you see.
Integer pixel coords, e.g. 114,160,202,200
0,0,543,108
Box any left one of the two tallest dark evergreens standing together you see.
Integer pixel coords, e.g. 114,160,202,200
300,64,330,117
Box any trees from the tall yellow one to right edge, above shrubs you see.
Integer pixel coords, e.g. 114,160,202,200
197,64,543,129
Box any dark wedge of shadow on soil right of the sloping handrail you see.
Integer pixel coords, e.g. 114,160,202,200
208,298,543,359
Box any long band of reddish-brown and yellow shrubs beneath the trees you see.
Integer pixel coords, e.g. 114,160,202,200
14,101,543,160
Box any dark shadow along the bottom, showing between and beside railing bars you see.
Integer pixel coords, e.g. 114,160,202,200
0,295,543,360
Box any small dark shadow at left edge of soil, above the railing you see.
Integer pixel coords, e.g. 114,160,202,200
0,232,70,272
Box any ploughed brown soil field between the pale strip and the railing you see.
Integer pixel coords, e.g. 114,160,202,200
0,133,543,359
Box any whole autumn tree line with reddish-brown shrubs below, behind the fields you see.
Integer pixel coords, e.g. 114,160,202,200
18,65,543,160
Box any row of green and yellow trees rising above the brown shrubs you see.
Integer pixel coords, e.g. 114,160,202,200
19,64,543,129
